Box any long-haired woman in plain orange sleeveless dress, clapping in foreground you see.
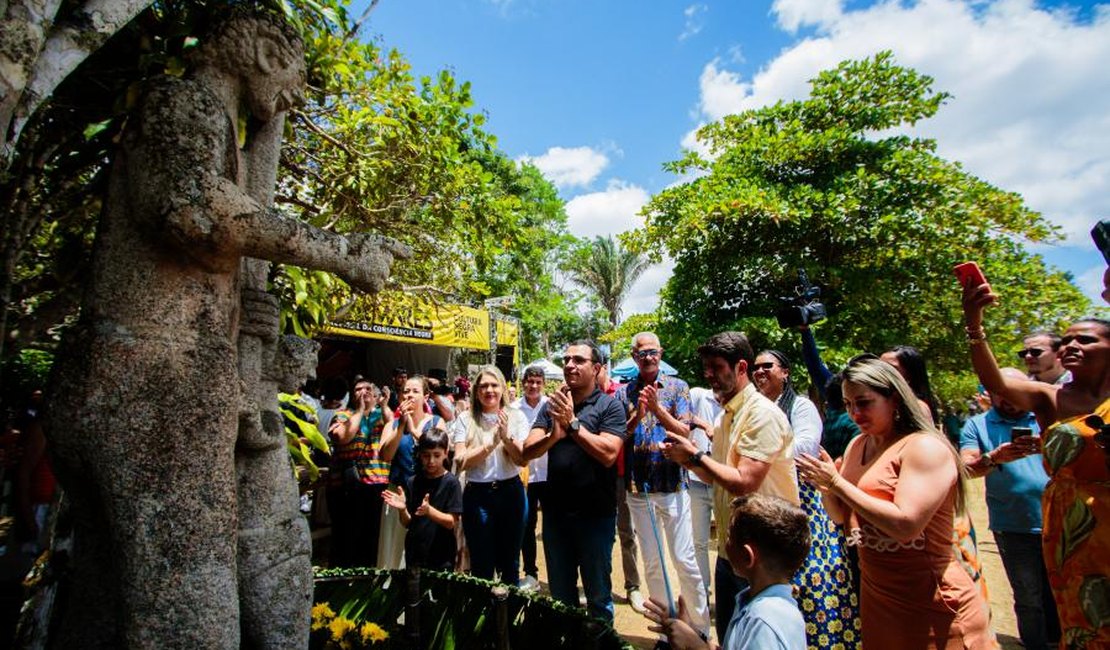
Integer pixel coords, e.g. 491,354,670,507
797,355,996,649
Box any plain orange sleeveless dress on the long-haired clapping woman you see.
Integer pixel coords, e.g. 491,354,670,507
840,434,997,650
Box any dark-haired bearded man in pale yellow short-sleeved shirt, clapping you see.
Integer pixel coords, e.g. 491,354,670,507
666,332,800,639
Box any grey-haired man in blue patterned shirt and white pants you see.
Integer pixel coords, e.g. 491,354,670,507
614,332,709,647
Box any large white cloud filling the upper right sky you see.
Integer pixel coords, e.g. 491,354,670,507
683,0,1110,246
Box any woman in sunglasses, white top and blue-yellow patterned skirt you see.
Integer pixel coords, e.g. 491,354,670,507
753,349,860,648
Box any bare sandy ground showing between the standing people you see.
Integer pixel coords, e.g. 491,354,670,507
537,479,1022,650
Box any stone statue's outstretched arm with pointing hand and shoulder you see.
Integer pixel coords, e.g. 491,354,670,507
132,81,412,291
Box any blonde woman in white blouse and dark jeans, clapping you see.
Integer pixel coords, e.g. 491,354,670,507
455,366,528,587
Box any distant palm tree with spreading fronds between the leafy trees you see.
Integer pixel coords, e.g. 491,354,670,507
568,235,652,328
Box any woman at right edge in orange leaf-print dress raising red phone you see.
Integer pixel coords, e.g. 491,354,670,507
963,277,1110,650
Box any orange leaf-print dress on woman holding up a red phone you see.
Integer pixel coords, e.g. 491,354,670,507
1041,399,1110,650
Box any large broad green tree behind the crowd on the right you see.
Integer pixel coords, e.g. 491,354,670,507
626,52,1089,397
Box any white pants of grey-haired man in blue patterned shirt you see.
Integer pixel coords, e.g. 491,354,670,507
628,490,709,632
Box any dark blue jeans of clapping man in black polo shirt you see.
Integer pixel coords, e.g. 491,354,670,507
543,512,617,624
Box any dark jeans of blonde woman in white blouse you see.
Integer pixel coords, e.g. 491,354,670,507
463,477,528,587
